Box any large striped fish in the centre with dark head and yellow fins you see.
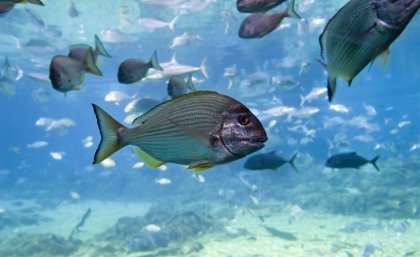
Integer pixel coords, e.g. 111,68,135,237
93,91,267,170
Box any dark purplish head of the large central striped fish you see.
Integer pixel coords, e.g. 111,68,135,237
220,103,267,157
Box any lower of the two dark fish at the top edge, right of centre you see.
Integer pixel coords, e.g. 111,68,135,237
239,0,299,38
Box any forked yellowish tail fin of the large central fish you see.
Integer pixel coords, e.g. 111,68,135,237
92,104,127,164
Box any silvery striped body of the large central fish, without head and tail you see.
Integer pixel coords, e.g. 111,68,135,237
123,92,236,164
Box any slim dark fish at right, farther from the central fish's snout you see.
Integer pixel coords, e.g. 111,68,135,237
325,152,379,171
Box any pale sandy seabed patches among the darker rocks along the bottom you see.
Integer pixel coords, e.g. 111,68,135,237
0,201,420,257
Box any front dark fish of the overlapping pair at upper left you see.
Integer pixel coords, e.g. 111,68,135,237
49,48,102,94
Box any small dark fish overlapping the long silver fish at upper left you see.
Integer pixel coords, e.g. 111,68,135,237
118,51,163,84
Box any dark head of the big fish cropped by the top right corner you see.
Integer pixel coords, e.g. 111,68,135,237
374,0,420,29
